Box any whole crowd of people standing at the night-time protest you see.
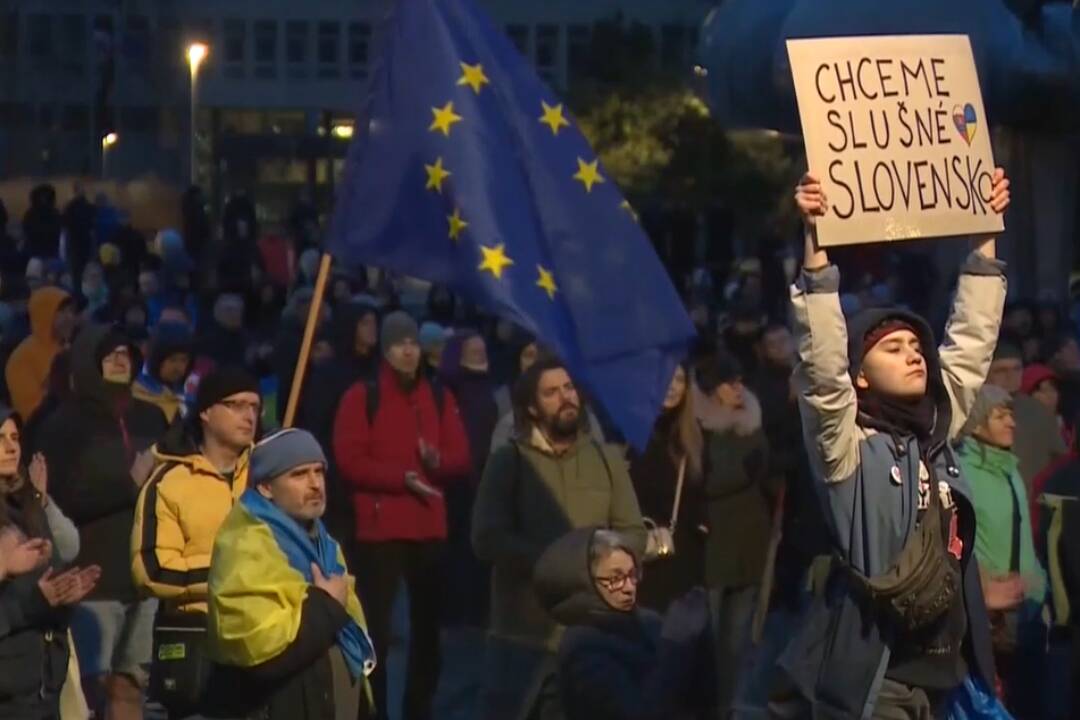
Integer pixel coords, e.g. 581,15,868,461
0,167,1080,720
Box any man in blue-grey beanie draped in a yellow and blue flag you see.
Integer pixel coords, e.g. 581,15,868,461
207,430,375,720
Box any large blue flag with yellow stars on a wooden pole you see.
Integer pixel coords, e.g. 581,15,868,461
326,0,693,447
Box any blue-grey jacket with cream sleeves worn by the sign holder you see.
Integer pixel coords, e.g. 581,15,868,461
780,254,1005,719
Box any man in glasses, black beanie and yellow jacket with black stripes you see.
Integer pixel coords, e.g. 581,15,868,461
131,367,261,719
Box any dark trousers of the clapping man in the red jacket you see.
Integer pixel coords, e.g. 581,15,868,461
353,541,443,720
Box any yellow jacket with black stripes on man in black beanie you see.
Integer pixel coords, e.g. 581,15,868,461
131,424,251,614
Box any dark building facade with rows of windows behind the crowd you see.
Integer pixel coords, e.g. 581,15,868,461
0,0,711,218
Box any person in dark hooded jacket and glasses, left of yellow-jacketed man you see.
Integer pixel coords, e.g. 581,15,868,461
38,325,166,719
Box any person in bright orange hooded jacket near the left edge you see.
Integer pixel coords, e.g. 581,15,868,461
4,287,76,418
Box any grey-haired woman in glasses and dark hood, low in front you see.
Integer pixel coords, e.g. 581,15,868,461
534,528,717,720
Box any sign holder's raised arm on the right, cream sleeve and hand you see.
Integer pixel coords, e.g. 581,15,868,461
937,167,1010,437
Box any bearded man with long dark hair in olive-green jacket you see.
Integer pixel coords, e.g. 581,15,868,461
472,359,646,720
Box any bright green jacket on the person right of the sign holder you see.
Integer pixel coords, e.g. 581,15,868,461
959,437,1047,603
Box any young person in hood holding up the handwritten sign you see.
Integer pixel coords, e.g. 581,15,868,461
772,169,1009,718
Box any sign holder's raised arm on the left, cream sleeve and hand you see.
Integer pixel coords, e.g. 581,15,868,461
792,174,859,483
